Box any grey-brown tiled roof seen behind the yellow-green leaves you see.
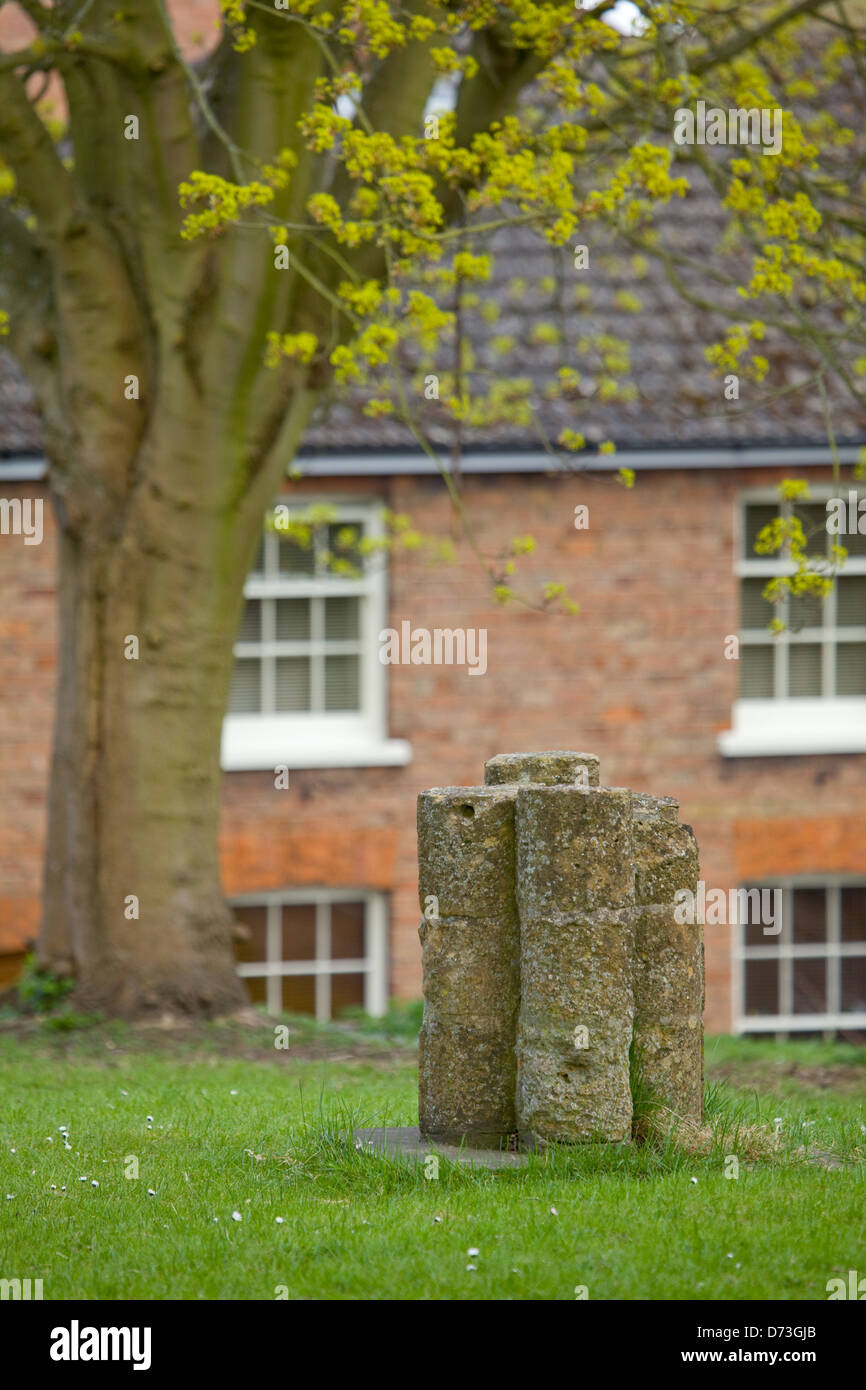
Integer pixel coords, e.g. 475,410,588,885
0,174,865,456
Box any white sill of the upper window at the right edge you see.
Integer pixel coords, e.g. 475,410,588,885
717,695,866,758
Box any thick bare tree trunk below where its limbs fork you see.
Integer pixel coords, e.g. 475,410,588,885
39,408,279,1016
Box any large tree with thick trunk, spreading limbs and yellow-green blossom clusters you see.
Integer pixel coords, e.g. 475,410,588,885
0,0,852,1013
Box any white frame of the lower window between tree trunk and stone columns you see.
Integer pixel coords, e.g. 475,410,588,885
229,888,388,1023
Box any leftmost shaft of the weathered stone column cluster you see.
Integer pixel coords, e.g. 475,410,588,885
418,787,520,1147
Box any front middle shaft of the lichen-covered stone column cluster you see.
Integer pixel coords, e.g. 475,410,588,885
517,784,634,1145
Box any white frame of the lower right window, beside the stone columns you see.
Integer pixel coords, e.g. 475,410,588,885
731,874,866,1033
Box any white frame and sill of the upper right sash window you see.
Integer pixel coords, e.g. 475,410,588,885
717,482,866,758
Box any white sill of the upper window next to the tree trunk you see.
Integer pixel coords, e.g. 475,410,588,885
220,714,411,773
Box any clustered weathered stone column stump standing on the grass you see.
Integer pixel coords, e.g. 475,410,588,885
418,752,703,1150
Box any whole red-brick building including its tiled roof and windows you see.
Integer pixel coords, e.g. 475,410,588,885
0,8,866,1036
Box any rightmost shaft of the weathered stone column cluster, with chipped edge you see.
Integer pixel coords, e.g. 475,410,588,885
632,794,703,1120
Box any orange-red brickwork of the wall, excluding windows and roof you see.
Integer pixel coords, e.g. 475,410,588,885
0,470,866,1030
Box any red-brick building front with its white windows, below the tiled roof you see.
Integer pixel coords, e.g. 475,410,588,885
0,428,866,1030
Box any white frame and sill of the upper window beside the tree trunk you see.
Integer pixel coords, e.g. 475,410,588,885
221,495,411,771
